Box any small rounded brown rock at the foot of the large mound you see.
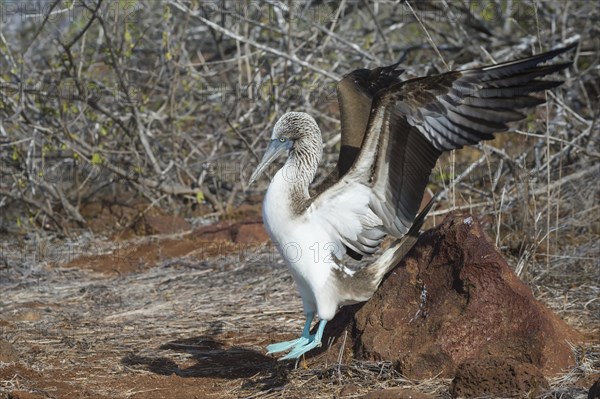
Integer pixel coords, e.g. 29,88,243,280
450,358,549,398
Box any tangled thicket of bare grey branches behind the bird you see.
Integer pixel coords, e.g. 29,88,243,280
0,0,600,322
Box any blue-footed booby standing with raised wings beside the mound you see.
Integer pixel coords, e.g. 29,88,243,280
250,43,577,359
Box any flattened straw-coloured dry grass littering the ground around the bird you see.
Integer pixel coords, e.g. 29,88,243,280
0,233,600,398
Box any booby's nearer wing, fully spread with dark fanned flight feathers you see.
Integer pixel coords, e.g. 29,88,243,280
310,43,577,254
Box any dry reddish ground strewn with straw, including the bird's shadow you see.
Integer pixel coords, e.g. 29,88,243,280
0,211,600,398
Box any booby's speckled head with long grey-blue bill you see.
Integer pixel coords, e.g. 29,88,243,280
249,112,321,184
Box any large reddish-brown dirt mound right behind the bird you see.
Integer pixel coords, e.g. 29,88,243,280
325,213,581,384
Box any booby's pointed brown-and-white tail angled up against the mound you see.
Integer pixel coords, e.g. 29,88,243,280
340,196,437,305
